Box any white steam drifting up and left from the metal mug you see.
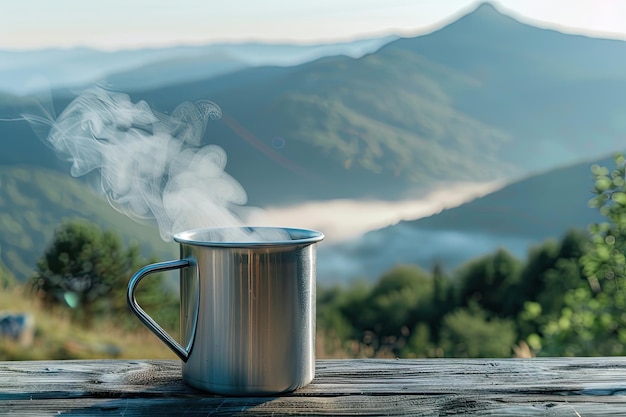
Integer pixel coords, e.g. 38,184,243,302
31,87,260,241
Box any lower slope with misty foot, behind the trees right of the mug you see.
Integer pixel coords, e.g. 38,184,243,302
318,154,613,283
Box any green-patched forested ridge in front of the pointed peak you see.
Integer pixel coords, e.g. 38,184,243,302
0,49,516,205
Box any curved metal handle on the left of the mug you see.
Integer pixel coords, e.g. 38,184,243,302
126,259,190,362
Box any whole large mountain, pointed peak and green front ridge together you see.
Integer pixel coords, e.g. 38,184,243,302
0,4,626,205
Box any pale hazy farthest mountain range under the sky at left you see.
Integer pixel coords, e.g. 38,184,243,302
0,36,396,95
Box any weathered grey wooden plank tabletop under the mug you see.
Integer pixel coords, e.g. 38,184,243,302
0,358,626,416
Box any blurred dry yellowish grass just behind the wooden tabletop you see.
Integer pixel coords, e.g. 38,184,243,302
0,286,531,361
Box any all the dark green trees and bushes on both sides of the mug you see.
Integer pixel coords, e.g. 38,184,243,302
0,154,626,359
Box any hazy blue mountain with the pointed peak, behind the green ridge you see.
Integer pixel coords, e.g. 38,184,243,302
379,3,626,170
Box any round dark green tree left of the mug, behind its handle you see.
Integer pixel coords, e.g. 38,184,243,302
30,220,173,326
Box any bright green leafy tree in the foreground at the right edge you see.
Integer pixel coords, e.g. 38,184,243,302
542,154,626,355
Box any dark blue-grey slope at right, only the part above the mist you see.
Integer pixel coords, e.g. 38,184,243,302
406,154,614,239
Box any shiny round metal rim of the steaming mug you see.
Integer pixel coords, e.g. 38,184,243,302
173,226,324,248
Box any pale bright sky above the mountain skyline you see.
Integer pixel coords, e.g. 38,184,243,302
0,0,626,50
